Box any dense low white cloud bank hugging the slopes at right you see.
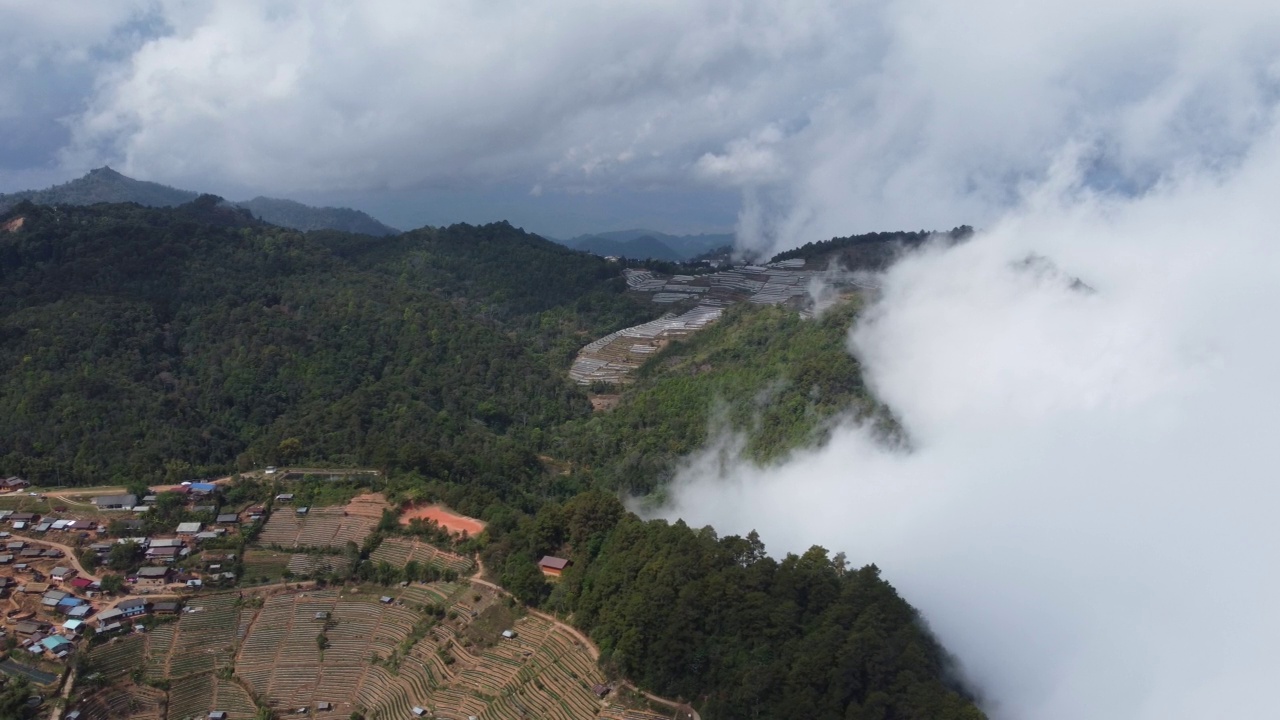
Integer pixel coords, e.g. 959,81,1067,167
667,129,1280,720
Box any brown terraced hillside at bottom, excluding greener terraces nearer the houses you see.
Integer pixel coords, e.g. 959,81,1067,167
226,583,617,720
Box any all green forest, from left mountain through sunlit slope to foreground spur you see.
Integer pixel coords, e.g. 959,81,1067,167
0,196,983,720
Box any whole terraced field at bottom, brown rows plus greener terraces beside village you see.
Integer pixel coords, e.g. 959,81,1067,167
78,576,657,720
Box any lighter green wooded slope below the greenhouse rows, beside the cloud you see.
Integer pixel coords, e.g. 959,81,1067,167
556,299,896,493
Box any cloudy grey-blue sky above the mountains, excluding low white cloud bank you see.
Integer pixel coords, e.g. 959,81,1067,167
0,0,1277,240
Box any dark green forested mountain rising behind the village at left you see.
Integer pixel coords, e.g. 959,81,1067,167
0,197,652,492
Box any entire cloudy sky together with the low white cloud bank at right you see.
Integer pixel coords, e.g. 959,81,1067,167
0,0,1280,720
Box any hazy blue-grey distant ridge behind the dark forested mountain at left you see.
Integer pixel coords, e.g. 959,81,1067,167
0,168,401,236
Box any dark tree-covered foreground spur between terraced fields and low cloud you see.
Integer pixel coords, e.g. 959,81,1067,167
485,492,983,720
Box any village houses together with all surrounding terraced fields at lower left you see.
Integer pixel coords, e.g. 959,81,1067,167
0,468,687,720
